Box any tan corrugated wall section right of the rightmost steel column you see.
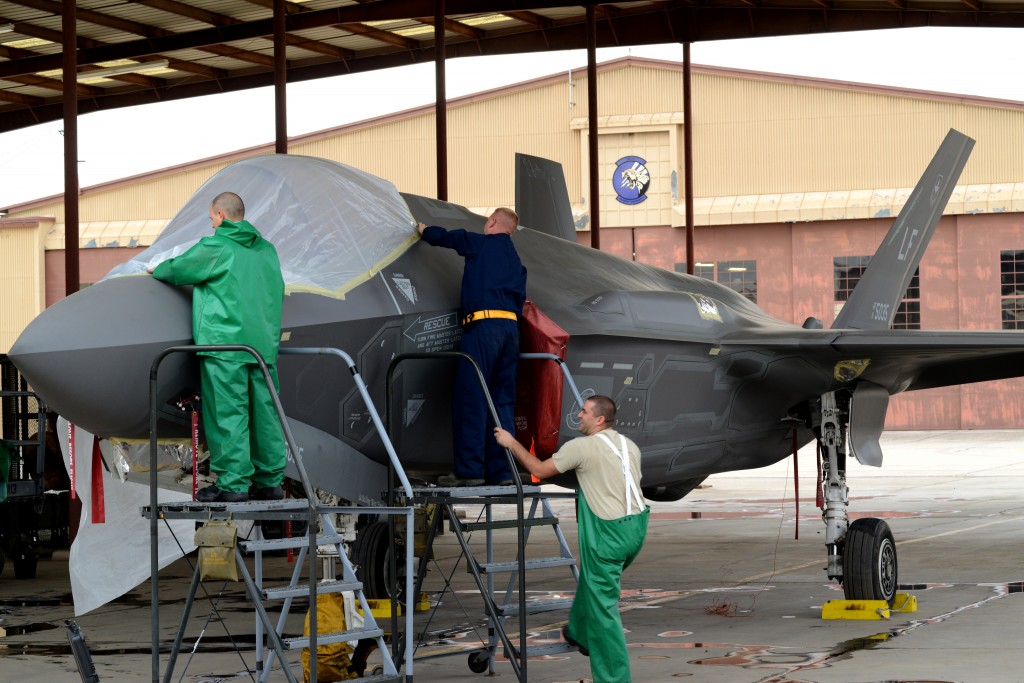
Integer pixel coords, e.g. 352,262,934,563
693,69,1024,197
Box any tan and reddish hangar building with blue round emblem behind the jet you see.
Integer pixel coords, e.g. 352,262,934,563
0,58,1024,429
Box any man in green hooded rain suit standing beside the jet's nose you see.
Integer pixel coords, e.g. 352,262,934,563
151,193,286,503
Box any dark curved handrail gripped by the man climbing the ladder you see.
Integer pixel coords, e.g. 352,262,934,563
385,351,527,681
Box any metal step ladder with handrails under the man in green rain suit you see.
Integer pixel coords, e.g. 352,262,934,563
142,345,414,683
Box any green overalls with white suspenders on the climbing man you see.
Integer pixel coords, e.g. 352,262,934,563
568,434,650,683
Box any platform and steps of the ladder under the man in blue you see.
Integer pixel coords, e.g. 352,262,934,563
414,485,580,681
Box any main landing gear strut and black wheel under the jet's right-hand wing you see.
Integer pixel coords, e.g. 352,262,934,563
815,391,899,605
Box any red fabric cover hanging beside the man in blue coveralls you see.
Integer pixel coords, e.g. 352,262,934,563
515,299,569,460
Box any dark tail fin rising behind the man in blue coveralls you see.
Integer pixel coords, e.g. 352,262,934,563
515,153,577,243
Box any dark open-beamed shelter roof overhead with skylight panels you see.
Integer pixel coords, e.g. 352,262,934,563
0,0,1024,132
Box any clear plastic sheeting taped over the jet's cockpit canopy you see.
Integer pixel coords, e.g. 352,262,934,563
104,155,419,297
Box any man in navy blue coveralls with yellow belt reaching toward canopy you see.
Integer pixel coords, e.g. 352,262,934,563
417,208,526,486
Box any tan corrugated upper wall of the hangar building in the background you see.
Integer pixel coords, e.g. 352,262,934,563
12,59,1024,229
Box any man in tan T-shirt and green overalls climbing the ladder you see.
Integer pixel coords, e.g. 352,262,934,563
495,396,650,683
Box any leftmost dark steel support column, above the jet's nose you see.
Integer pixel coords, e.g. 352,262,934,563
60,0,82,296
